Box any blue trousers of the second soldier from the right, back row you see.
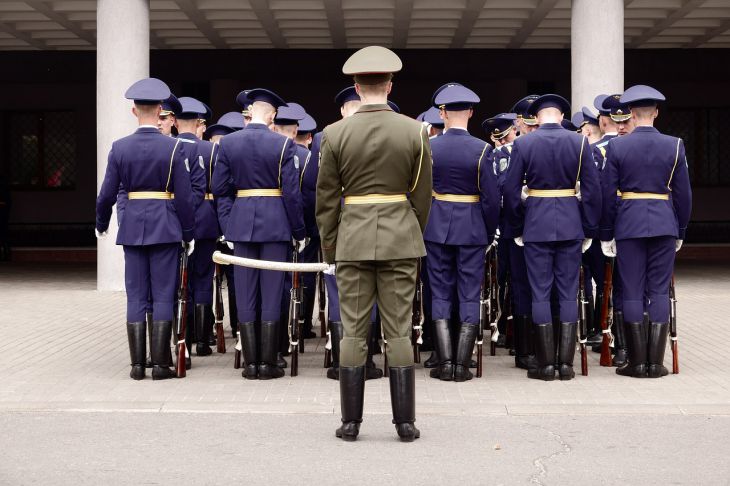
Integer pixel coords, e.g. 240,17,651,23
525,240,581,324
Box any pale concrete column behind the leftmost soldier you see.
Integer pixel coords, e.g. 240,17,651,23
96,0,150,290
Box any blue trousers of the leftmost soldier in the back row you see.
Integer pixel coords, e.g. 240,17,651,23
124,243,182,322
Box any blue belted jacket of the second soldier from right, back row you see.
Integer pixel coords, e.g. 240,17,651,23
504,123,601,243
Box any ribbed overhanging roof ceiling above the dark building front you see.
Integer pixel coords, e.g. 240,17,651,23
0,0,730,49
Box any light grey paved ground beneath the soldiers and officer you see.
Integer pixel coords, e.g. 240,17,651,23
0,263,730,484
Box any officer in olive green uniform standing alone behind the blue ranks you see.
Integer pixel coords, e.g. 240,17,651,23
316,46,432,442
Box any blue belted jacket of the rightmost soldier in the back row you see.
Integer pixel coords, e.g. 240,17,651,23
601,127,692,241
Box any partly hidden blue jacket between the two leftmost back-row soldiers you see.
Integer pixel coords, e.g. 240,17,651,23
178,133,220,240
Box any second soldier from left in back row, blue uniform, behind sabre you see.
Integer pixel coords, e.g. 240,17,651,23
213,88,305,380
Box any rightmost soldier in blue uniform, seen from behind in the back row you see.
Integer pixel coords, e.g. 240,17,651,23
601,85,692,378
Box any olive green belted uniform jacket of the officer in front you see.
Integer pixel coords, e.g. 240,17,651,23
316,105,432,263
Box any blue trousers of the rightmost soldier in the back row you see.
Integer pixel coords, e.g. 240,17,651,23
616,236,676,322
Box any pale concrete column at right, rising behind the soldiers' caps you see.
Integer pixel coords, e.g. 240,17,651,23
570,0,624,112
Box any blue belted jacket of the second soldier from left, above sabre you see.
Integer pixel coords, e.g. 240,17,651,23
213,123,305,242
